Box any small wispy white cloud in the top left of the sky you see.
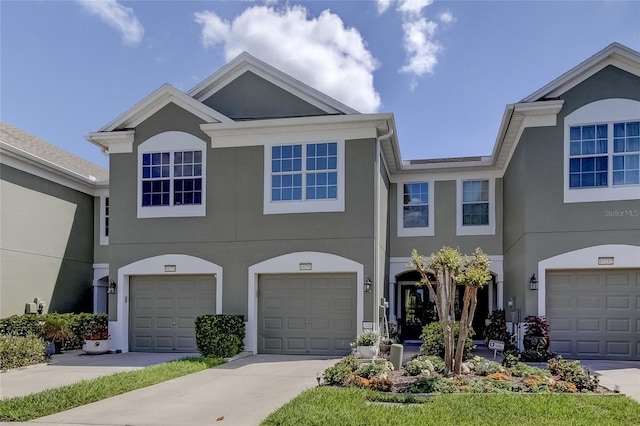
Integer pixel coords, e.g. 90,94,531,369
76,0,144,46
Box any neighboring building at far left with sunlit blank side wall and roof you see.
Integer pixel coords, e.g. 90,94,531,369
0,122,109,318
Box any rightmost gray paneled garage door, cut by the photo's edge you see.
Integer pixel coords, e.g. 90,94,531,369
546,269,640,360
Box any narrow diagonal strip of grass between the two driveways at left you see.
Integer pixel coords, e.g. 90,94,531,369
0,358,224,422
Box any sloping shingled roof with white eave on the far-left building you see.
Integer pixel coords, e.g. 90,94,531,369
0,121,109,183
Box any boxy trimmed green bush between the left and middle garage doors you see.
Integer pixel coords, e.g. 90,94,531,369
195,315,245,358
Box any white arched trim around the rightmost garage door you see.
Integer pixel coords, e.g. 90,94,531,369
538,244,640,316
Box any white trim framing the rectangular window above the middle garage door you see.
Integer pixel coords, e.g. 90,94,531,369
263,141,345,214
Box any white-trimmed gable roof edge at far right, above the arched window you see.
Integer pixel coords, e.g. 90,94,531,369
520,43,640,103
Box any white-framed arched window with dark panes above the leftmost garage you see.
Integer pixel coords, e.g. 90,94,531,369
137,131,206,218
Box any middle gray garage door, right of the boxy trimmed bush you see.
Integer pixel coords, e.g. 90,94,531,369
258,274,356,355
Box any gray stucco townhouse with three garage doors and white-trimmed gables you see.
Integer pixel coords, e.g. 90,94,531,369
2,43,640,360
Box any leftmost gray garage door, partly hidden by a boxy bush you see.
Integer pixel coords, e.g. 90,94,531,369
129,275,216,352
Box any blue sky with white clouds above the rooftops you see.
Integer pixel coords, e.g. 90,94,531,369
0,0,640,167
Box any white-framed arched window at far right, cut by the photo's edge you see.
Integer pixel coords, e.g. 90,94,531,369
564,99,640,203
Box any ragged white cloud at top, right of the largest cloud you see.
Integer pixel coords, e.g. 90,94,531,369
378,0,455,89
